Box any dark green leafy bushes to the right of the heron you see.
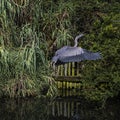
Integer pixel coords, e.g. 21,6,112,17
74,2,120,101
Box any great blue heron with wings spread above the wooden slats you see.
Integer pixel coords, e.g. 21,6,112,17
52,34,101,65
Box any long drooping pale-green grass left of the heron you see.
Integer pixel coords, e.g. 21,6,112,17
0,0,59,97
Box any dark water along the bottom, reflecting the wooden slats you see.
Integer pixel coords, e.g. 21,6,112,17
0,94,120,120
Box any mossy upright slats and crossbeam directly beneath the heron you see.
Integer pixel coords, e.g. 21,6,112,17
53,62,81,83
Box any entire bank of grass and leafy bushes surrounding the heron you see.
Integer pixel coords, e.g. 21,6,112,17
0,0,120,100
